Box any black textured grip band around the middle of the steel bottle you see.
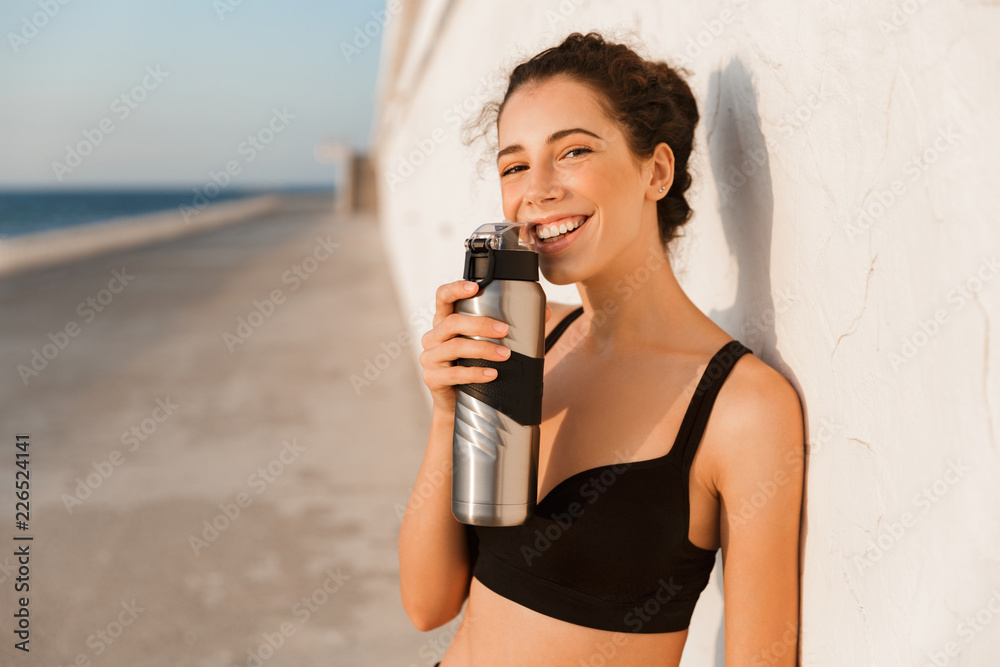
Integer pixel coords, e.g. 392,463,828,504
455,350,545,426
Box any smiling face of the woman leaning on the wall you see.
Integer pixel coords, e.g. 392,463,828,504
497,77,658,285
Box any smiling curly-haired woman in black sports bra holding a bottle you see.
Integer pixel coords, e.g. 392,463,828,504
399,33,803,667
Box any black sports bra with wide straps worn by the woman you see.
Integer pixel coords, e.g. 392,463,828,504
466,307,750,633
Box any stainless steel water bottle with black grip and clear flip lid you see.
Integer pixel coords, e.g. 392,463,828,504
451,220,545,526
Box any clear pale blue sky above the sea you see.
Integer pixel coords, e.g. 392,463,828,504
0,0,392,189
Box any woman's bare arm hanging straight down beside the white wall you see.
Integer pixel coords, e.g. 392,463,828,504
716,362,805,666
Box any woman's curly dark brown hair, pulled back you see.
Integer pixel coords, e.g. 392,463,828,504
479,32,700,250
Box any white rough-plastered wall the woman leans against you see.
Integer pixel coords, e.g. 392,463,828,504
373,0,1000,667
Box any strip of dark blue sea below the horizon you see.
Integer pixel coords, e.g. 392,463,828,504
0,187,332,238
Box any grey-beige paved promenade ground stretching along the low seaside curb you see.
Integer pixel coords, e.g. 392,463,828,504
0,197,453,667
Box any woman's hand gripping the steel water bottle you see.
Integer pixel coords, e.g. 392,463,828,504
420,280,510,413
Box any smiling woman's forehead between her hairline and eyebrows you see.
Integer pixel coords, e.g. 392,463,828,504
497,77,617,148
